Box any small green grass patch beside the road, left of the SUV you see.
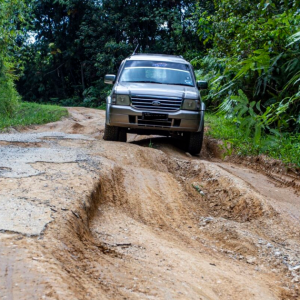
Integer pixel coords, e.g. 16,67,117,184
0,102,68,131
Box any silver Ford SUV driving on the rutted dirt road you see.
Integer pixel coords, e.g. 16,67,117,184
104,54,207,154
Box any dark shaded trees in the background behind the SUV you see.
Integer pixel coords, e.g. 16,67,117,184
17,0,202,107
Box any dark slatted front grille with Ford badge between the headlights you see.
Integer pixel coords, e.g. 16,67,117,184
131,95,182,111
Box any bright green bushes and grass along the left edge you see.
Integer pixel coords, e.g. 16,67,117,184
0,0,68,131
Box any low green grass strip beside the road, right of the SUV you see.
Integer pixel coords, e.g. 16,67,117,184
206,113,300,167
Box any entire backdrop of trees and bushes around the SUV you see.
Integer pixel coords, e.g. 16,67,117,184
0,0,300,164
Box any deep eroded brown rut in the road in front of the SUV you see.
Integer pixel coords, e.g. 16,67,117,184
44,143,300,300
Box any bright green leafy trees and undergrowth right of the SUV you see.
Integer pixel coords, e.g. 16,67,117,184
192,0,300,163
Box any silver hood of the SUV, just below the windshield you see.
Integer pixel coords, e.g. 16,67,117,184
114,82,200,100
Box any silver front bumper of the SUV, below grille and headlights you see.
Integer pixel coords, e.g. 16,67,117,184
106,103,205,132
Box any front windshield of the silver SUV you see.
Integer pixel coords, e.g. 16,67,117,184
119,60,194,86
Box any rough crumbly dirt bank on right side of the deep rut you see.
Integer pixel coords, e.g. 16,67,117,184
168,160,276,222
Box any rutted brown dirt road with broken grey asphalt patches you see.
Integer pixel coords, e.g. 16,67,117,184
0,108,300,300
